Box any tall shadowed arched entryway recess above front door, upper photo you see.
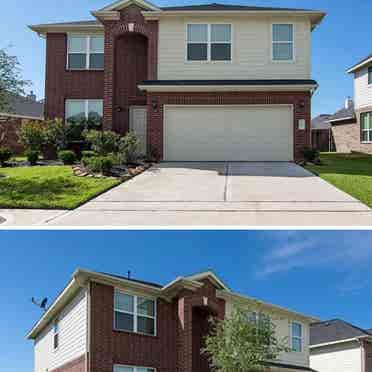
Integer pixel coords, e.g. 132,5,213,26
112,32,148,134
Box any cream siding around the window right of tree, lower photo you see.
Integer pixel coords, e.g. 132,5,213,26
226,302,310,367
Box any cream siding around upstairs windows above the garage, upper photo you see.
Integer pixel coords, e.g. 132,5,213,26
158,16,311,79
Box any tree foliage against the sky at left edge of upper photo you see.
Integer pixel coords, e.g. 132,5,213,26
0,49,30,112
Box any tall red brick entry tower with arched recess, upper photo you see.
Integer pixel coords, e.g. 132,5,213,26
103,5,158,132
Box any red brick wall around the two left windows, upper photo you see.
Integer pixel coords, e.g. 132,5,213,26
45,33,104,118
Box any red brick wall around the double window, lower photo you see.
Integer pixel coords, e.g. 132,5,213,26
90,283,177,372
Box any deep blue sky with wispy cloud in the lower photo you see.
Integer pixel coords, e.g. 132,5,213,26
0,231,372,372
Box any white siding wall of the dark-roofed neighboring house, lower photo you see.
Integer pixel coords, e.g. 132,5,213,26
310,342,362,372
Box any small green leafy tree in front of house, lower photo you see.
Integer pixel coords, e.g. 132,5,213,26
202,308,289,372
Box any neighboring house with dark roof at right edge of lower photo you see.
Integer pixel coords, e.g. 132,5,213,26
310,319,372,372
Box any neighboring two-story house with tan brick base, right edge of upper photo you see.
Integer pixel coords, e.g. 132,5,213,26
330,55,372,154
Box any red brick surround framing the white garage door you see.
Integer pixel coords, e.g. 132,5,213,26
147,92,311,161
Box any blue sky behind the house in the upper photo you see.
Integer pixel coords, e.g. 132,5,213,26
0,0,372,115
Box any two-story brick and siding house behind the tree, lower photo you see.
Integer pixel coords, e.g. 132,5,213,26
27,269,317,372
